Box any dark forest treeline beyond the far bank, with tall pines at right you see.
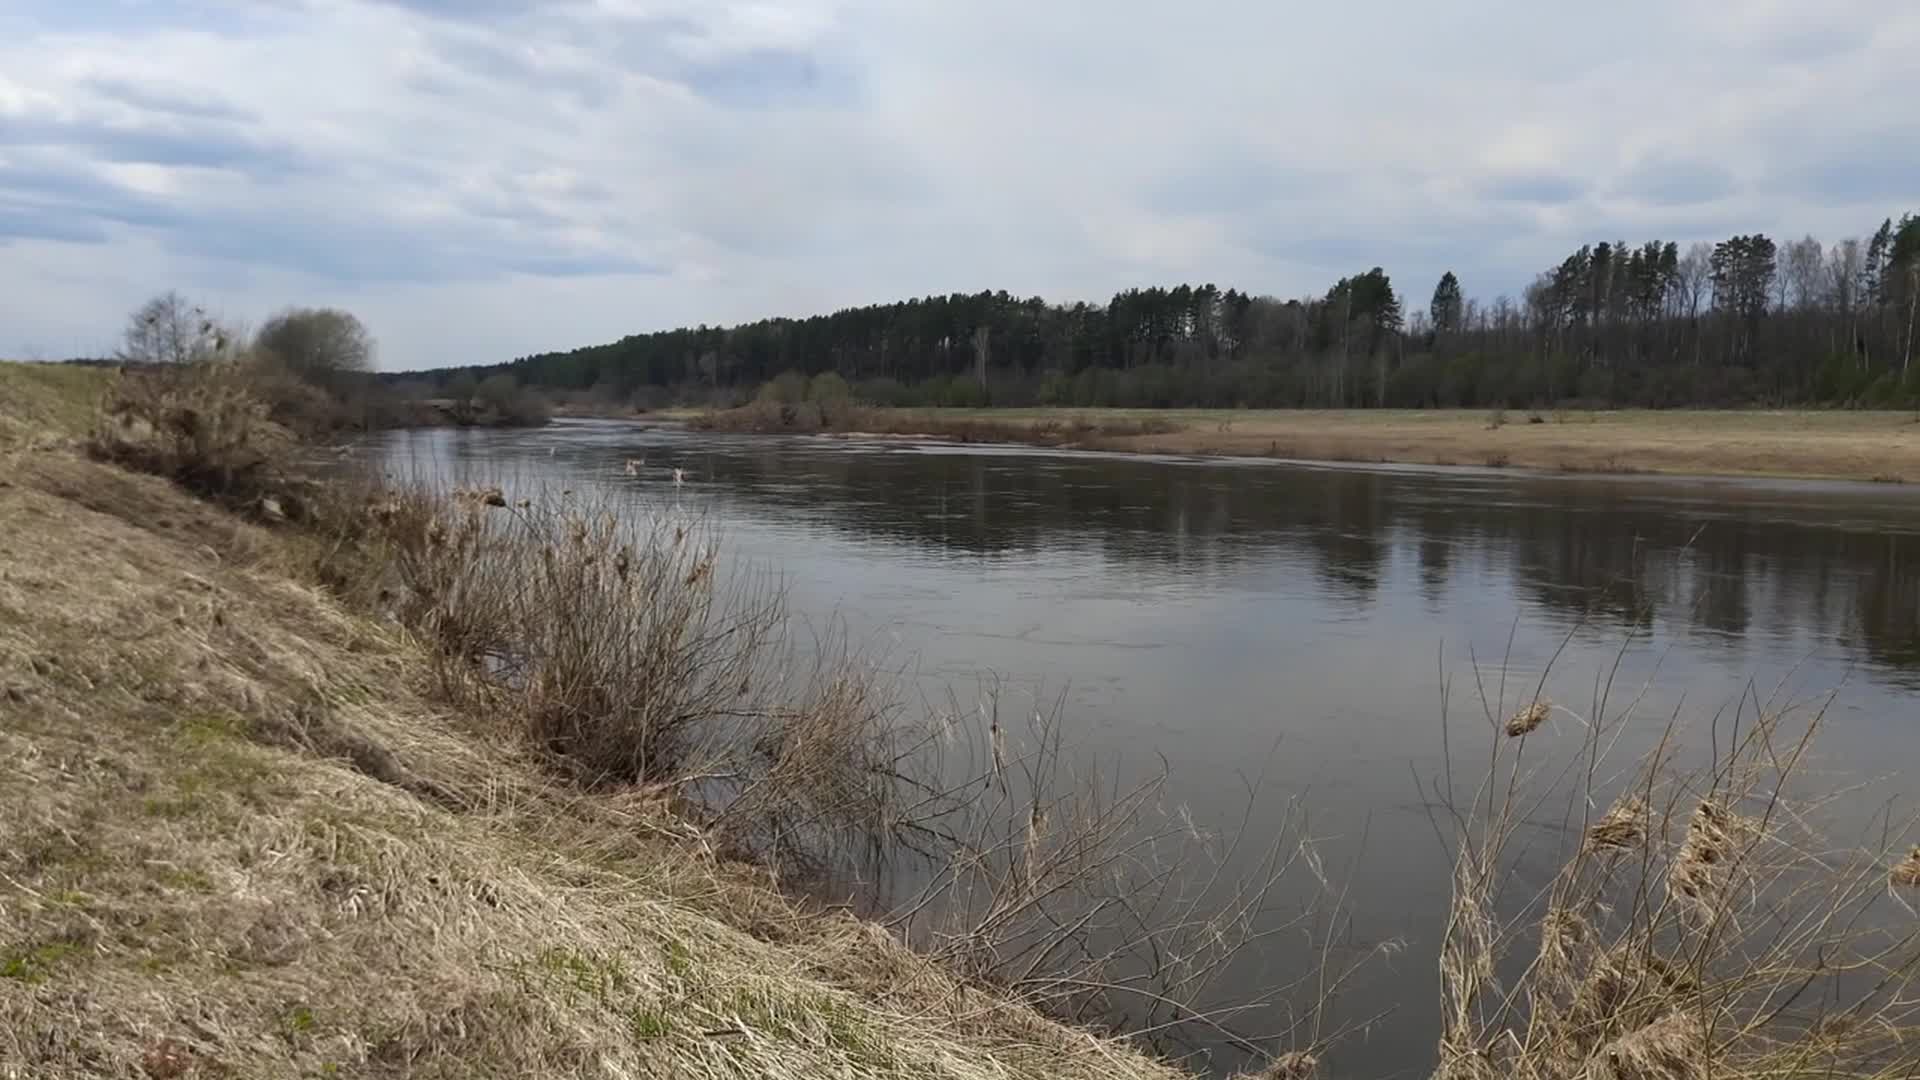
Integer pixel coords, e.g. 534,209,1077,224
430,213,1920,407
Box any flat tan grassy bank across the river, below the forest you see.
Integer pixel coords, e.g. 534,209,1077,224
691,407,1920,482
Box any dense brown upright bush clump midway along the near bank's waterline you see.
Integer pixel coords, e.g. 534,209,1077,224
349,478,929,882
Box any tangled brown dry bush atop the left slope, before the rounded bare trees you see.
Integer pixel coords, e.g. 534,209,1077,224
88,359,294,505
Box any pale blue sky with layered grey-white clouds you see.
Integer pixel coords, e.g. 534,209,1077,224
0,0,1920,369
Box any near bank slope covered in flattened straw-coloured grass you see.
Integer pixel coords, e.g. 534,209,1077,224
0,363,1171,1078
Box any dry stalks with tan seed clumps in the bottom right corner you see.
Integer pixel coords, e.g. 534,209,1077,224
1434,641,1920,1080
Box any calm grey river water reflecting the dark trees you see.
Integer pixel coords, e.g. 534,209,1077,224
366,421,1920,1076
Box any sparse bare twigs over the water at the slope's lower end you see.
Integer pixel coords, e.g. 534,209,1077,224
889,690,1367,1061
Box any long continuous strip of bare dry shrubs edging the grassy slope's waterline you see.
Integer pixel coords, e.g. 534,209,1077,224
341,476,1344,1053
